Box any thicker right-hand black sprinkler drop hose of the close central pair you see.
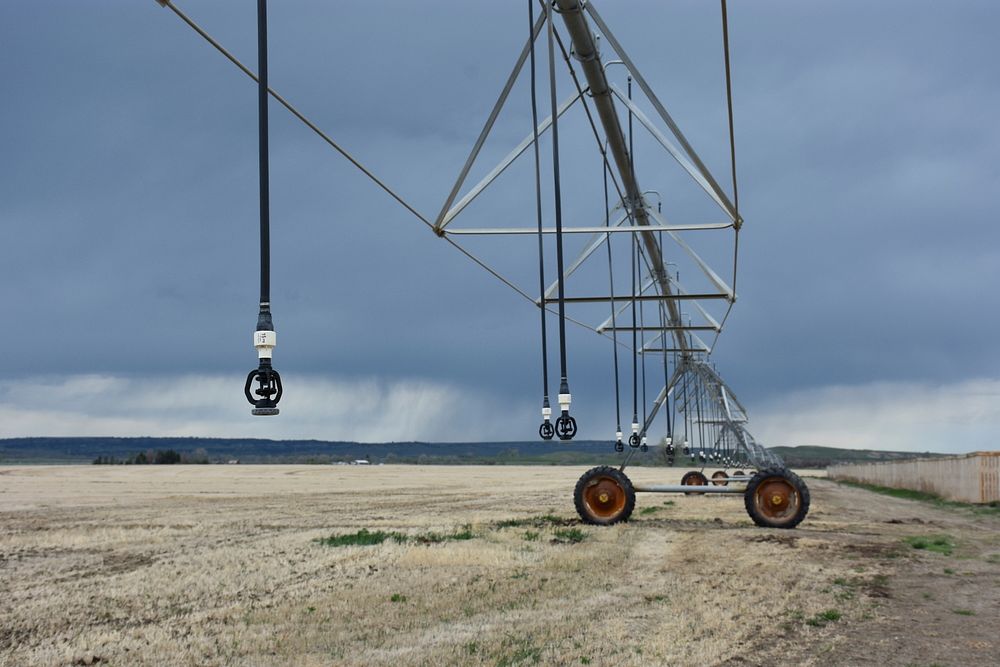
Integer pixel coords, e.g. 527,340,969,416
545,3,577,440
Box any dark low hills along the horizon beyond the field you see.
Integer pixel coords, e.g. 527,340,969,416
0,438,942,468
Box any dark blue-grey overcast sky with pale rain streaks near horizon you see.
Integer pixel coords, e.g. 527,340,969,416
0,0,1000,451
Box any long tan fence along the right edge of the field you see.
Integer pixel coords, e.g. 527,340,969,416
827,452,1000,503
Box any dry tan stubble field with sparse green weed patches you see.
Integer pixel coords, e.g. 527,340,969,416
0,466,1000,666
